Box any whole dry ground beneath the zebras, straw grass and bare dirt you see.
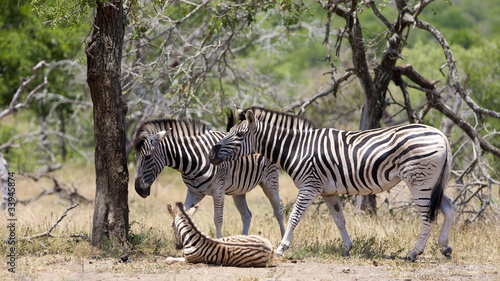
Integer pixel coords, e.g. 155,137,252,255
6,173,500,281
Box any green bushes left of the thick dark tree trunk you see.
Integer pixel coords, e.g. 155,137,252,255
0,0,93,167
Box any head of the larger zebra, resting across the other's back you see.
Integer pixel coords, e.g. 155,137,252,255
209,110,259,165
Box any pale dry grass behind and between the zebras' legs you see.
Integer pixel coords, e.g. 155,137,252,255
0,165,500,280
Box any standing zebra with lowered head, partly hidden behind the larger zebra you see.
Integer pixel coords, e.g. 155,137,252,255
134,119,285,238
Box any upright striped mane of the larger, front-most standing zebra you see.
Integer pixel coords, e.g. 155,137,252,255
237,106,316,130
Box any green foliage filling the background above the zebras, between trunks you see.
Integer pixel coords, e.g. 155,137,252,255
0,0,500,172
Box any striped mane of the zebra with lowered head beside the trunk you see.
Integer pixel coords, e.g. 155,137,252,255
134,119,209,151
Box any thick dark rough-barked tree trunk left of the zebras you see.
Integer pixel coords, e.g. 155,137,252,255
85,0,129,248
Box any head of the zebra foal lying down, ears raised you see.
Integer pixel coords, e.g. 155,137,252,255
167,202,198,250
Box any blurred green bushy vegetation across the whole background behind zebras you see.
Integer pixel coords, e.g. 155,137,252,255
0,0,500,166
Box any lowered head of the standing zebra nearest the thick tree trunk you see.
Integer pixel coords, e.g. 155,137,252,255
135,129,171,198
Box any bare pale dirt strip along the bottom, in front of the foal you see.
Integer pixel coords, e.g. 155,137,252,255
8,259,500,281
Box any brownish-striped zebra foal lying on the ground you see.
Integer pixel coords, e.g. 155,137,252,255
167,202,272,267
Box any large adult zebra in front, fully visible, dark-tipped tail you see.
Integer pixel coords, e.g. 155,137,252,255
210,107,456,261
